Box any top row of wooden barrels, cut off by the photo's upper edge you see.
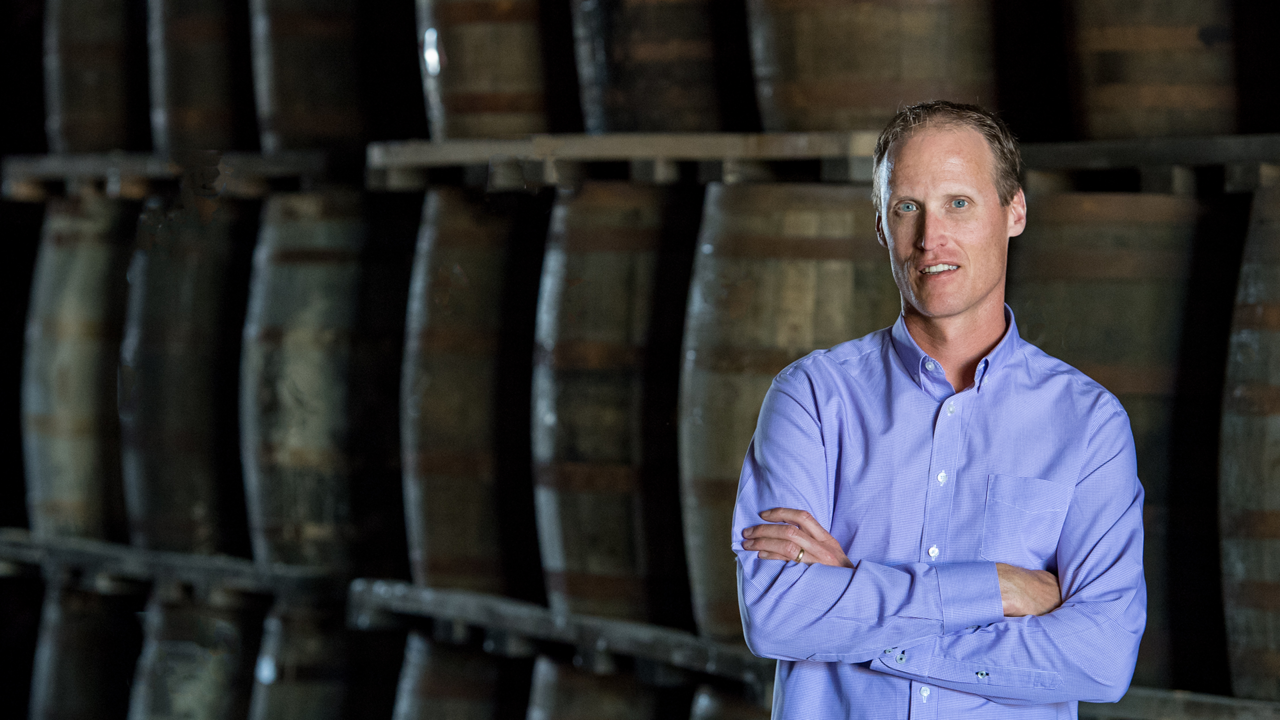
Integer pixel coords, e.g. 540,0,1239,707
45,0,1236,149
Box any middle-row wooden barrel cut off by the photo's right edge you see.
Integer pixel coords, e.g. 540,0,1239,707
1217,183,1280,701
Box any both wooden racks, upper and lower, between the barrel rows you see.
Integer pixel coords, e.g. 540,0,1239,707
0,132,1280,720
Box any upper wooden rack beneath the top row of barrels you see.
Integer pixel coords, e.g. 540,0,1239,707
3,132,1280,201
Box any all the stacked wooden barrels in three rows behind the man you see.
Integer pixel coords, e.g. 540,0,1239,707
10,0,1280,720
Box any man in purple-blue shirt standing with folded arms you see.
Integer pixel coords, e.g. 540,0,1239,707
733,101,1146,720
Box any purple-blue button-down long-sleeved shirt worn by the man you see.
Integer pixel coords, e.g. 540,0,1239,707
733,306,1147,720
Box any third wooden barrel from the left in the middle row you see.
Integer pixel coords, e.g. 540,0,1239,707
241,191,365,570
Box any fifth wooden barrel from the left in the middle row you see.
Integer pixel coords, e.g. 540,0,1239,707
532,182,663,620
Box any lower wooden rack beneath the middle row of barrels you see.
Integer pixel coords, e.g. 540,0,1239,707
0,528,1280,720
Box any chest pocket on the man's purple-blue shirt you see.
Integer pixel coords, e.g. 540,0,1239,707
980,475,1075,570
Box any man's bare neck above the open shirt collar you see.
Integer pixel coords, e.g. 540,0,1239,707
904,299,1009,392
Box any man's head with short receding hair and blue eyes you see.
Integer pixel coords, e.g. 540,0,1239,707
874,102,1027,328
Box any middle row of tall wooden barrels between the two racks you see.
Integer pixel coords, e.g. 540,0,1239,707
23,176,1276,697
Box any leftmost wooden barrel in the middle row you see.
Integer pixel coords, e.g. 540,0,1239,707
22,196,133,539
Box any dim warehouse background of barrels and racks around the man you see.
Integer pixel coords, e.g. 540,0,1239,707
0,0,1280,720
